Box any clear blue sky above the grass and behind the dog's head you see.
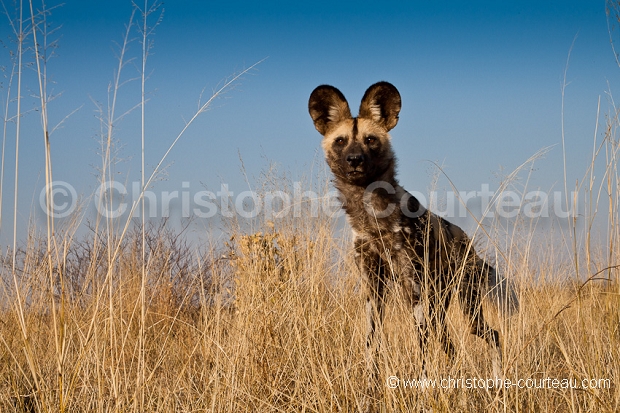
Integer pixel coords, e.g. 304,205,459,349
0,0,620,242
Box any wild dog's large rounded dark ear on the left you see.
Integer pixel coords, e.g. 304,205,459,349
308,85,351,135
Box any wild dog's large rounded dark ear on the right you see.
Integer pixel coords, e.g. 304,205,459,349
359,82,401,130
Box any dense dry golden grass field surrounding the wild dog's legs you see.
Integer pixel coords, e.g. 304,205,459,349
0,185,620,412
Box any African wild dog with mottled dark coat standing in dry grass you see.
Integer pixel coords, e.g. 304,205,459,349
308,82,517,396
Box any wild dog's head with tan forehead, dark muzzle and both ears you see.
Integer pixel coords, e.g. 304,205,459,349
308,82,401,186
